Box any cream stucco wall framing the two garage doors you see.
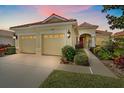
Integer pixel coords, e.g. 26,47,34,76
15,24,75,54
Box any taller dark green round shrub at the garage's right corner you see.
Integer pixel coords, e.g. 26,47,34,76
62,45,75,62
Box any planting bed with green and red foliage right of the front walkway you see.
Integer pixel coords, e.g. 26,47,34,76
90,40,124,77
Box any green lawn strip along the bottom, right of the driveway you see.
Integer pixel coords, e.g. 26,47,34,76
40,70,124,88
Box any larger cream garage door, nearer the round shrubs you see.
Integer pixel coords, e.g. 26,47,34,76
42,33,65,55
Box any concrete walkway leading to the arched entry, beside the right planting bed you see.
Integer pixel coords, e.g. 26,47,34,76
84,49,117,78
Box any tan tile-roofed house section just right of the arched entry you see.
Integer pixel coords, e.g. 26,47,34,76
96,30,112,45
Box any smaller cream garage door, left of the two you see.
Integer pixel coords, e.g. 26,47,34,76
19,35,36,53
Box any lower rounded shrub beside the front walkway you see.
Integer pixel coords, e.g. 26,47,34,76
74,53,89,66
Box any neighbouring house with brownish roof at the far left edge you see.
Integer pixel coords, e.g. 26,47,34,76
0,30,14,46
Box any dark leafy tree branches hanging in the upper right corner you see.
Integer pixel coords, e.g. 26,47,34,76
102,5,124,30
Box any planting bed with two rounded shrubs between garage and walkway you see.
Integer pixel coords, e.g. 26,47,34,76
61,45,90,66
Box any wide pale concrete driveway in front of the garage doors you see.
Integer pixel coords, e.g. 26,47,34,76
0,54,60,88
